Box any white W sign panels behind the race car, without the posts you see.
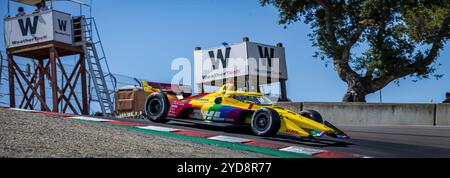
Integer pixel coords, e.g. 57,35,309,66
194,42,288,83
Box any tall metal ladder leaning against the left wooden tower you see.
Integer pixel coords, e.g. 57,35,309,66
73,17,116,115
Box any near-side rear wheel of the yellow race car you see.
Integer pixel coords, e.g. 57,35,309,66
144,93,170,123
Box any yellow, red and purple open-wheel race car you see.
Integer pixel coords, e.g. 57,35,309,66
144,85,350,139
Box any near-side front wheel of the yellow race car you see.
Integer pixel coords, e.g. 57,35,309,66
251,108,281,137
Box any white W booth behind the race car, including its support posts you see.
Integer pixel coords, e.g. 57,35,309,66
194,38,288,100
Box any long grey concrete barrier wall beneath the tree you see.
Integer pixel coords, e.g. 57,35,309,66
279,102,450,126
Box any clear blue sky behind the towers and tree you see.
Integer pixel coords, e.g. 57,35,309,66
0,0,450,103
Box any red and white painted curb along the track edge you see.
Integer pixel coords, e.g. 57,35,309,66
1,107,370,158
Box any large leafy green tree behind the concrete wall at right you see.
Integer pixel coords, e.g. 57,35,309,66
260,0,450,102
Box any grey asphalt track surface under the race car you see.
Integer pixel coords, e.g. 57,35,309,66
109,119,450,158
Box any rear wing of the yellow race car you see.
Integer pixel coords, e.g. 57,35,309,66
142,81,192,97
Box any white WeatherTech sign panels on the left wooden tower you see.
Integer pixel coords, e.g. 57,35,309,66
4,11,72,48
